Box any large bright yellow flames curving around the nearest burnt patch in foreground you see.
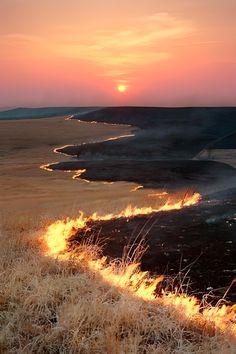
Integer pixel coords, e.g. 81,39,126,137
40,193,236,336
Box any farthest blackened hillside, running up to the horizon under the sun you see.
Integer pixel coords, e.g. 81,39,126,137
59,107,236,160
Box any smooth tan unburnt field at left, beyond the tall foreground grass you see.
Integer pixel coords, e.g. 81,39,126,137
0,117,136,217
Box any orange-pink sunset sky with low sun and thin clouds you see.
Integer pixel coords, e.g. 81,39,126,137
0,0,236,108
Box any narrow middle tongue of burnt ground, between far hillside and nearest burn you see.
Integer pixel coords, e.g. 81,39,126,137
50,159,236,193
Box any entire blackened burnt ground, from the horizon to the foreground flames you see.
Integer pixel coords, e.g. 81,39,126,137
43,107,236,302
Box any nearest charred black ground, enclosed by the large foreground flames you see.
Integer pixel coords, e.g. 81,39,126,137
70,189,236,303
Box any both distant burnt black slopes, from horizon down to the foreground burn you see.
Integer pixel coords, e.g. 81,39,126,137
47,107,236,192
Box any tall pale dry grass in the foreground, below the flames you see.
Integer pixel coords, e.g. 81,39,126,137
0,218,236,354
